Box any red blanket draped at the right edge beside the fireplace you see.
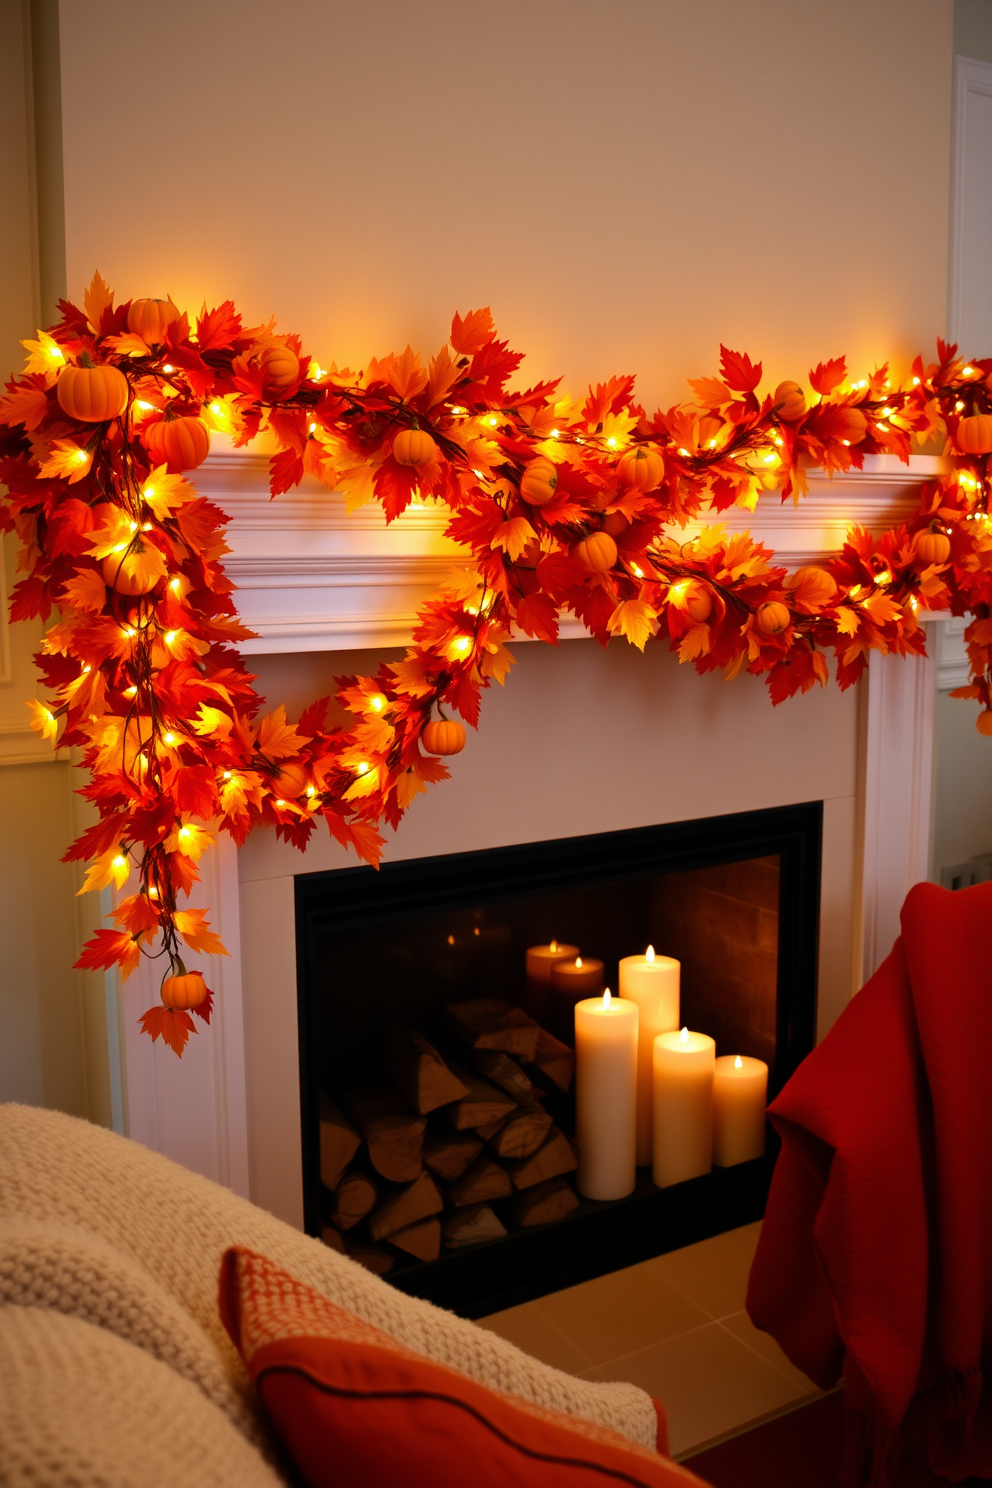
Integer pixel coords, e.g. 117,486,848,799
747,884,992,1484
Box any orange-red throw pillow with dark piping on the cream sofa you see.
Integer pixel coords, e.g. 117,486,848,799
220,1245,700,1488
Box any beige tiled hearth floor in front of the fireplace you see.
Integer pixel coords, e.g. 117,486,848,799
482,1225,819,1457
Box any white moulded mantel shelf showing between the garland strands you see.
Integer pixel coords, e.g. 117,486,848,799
192,436,941,655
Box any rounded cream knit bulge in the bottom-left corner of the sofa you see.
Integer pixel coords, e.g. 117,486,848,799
0,1305,283,1488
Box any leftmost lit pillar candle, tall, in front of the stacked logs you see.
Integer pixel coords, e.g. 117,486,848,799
576,988,638,1199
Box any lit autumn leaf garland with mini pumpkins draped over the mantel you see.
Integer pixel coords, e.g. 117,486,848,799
0,275,992,1054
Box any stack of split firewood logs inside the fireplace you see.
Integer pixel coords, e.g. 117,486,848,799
320,998,579,1275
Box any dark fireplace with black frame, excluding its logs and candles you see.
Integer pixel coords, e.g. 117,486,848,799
296,802,822,1317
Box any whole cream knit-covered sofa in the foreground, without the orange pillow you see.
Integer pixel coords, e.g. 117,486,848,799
0,1104,675,1488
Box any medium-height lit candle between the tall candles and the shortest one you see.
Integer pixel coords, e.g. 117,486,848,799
653,1028,717,1189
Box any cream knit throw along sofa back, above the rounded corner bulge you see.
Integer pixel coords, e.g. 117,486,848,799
0,1106,656,1464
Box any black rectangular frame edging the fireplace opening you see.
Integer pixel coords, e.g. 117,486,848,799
294,801,822,1317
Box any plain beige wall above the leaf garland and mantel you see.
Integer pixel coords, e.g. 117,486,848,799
62,0,952,402
